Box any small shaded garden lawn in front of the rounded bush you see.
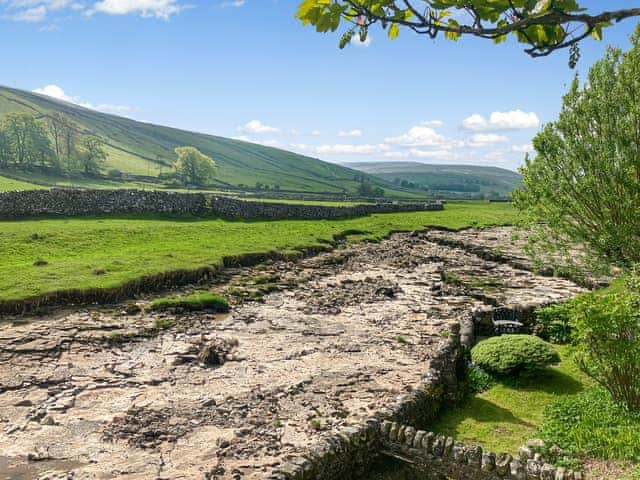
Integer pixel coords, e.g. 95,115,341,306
430,346,590,453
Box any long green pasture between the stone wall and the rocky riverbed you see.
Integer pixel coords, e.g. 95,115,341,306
0,202,516,301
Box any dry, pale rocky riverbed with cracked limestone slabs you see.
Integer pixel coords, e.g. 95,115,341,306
0,229,582,479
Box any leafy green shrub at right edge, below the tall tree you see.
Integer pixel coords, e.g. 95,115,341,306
571,284,640,411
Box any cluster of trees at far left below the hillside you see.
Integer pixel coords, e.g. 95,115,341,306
0,113,107,175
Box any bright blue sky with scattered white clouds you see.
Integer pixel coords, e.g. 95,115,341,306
0,0,637,169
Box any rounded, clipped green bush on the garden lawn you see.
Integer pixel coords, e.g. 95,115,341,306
471,335,560,375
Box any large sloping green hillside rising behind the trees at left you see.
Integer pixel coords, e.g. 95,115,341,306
0,87,421,197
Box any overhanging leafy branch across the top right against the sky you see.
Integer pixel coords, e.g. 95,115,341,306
296,0,640,61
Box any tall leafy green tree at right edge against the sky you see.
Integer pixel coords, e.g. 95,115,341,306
514,26,640,267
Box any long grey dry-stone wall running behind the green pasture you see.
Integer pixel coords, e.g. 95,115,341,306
0,189,443,219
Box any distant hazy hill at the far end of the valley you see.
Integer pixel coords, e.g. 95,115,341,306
348,162,522,198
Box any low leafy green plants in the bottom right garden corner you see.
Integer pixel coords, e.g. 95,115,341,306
541,388,640,462
